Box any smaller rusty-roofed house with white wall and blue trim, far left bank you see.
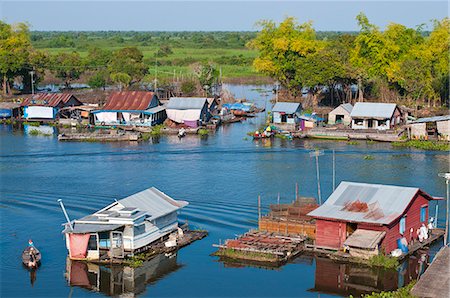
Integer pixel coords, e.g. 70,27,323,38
21,93,83,120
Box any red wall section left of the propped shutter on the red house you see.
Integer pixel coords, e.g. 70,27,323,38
316,219,346,249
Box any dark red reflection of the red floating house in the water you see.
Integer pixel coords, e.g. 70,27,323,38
310,252,429,296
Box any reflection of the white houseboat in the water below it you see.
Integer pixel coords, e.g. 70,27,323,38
65,254,182,296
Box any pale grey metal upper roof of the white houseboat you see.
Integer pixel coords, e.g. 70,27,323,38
118,187,188,219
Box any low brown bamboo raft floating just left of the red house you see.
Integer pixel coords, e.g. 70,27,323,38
213,230,306,266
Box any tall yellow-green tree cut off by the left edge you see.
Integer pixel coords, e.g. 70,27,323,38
0,21,31,95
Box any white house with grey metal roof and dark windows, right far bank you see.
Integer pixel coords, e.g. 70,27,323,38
350,102,403,130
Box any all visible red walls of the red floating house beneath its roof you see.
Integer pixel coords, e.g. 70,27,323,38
316,193,429,254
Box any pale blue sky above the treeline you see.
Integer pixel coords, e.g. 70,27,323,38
0,0,449,31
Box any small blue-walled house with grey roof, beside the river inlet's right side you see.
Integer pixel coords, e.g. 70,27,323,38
272,102,302,131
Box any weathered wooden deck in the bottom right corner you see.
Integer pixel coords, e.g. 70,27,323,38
411,246,450,298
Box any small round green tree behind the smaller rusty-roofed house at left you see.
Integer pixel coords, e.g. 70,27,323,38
51,52,85,88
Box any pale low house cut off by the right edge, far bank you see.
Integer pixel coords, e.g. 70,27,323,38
410,115,450,141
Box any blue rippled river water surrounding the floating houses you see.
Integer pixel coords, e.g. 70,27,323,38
0,85,449,297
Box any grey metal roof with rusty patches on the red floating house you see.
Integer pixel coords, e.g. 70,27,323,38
308,182,429,224
